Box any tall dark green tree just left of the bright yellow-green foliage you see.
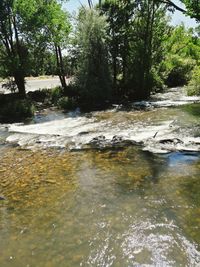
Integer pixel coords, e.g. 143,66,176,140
126,0,168,99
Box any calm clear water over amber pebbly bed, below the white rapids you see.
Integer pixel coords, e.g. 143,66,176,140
0,147,200,267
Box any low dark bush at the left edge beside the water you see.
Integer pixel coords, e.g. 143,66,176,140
0,99,35,123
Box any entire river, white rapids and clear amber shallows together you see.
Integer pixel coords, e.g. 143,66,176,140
0,88,200,267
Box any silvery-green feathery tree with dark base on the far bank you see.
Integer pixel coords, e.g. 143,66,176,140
75,9,111,109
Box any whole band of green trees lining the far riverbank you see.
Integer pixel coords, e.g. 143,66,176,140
0,0,200,119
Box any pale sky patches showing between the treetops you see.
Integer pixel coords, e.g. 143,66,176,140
65,0,197,27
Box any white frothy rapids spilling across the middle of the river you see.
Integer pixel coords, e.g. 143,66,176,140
4,103,200,153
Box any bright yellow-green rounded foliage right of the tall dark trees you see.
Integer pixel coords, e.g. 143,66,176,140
162,25,200,87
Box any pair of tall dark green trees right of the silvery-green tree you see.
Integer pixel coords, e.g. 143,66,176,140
102,0,168,99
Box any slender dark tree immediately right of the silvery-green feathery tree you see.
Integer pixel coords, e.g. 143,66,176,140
101,0,136,90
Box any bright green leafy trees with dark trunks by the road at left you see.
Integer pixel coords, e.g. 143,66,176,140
0,0,70,97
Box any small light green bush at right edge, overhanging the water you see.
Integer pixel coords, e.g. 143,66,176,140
187,66,200,96
